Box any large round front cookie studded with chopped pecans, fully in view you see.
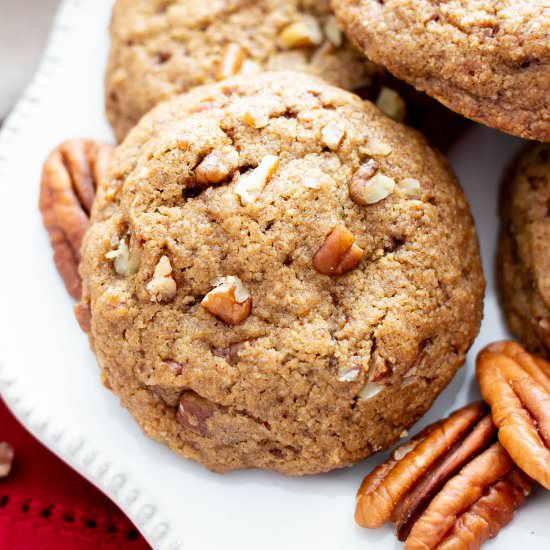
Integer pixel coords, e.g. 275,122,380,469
81,72,484,475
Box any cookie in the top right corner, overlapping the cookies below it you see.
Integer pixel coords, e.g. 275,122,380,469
333,0,550,141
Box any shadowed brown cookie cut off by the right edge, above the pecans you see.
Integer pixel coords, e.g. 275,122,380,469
497,143,550,357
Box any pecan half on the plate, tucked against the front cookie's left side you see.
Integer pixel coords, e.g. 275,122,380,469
39,139,113,300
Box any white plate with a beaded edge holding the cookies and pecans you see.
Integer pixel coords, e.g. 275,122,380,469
0,0,550,550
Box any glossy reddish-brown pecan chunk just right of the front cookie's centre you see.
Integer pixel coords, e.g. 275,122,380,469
313,224,363,275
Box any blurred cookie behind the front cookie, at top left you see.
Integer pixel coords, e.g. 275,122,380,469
106,0,380,139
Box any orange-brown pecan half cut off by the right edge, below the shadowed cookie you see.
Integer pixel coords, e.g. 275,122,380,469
477,342,550,489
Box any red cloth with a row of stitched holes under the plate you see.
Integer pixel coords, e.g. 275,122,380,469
0,399,150,550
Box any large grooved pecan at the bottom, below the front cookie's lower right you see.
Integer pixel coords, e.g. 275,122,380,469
355,403,530,550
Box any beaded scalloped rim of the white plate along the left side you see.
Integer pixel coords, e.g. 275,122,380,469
0,0,183,550
